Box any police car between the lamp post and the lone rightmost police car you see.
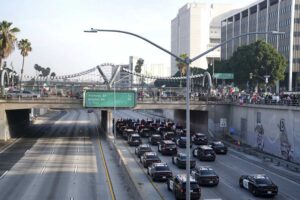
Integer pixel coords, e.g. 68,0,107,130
191,166,219,186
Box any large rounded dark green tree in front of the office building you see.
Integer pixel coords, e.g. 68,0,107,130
229,40,287,88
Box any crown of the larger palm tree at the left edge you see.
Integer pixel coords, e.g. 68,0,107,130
0,21,20,67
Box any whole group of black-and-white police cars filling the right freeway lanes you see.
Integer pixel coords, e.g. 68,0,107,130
115,119,278,199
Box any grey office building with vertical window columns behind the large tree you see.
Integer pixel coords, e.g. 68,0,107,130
221,0,300,91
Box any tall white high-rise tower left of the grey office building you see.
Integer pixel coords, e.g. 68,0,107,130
171,3,237,75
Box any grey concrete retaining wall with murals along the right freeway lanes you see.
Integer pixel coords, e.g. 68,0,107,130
230,105,300,163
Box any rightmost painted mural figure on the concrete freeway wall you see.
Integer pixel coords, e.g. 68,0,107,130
278,119,293,161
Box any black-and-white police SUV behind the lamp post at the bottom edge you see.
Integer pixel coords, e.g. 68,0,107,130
167,174,201,200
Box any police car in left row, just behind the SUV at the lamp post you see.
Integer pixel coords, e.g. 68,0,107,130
147,163,173,181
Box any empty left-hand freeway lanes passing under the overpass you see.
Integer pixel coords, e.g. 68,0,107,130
0,110,134,200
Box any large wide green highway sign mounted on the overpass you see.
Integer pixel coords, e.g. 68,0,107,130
83,90,136,108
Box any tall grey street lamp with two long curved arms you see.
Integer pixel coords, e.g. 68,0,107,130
84,28,285,200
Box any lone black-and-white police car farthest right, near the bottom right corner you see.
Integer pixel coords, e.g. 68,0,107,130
239,174,278,197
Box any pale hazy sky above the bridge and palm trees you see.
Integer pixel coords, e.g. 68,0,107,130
0,0,253,75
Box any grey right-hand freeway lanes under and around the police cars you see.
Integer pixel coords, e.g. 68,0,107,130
117,111,300,200
